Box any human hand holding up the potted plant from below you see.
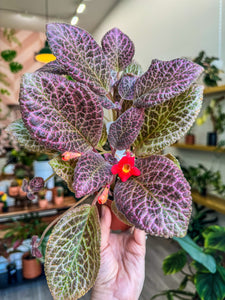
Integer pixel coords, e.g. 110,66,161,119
91,205,146,300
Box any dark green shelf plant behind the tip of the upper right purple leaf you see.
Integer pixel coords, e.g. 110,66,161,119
193,51,223,86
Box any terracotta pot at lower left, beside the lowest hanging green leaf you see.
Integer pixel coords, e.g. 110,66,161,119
22,253,42,279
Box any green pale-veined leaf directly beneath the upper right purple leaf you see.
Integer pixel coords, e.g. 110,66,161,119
133,85,203,157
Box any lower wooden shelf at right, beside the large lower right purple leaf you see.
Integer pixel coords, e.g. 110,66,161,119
191,191,225,214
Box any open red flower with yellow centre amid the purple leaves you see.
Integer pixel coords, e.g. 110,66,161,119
111,151,141,182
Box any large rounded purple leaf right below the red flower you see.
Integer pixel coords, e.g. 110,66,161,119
114,155,192,238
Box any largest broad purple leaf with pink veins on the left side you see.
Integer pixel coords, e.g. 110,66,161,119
20,73,103,152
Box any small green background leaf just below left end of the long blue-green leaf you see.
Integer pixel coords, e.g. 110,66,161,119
163,250,187,275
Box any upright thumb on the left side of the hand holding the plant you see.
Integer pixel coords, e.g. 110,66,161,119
100,205,112,250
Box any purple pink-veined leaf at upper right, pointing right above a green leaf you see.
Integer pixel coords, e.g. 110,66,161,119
134,58,203,107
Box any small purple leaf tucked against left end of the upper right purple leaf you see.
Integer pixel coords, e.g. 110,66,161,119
118,75,137,100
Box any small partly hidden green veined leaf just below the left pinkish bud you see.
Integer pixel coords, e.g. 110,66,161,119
49,157,77,192
